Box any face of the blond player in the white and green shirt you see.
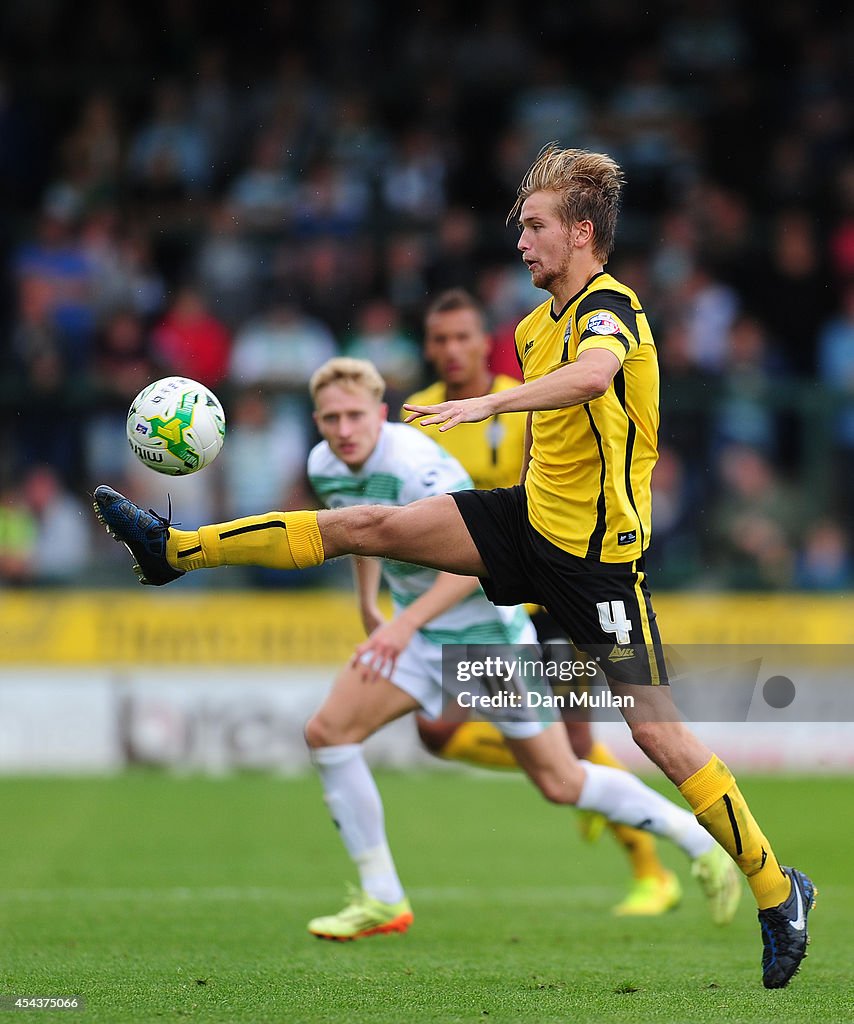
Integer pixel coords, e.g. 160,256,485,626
314,384,388,470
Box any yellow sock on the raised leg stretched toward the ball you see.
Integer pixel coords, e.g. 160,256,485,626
166,512,324,570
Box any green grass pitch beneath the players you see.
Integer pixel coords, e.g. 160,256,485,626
0,772,854,1024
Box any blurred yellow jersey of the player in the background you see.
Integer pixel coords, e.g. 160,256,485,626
401,374,527,490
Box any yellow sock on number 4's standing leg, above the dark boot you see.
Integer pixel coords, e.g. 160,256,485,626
679,755,792,910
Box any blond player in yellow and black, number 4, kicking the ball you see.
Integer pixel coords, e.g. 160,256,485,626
94,145,815,988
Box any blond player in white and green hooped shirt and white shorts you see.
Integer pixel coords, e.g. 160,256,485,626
296,358,739,940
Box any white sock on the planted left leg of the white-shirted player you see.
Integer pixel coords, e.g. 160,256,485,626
311,743,403,903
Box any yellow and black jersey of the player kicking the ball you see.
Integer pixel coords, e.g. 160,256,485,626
511,271,658,562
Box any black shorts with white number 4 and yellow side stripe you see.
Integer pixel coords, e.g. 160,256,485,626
451,486,668,684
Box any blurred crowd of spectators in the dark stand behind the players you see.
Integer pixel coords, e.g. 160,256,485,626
0,0,854,590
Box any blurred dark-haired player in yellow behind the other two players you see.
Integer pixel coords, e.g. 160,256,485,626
407,288,681,916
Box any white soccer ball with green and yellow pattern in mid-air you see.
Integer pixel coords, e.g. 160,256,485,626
127,377,225,476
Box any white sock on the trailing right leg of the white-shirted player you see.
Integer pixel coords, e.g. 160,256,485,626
575,761,715,858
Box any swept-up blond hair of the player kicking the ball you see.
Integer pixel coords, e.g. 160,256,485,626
507,142,626,263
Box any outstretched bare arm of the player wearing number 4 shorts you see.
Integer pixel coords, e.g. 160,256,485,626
404,348,620,431
